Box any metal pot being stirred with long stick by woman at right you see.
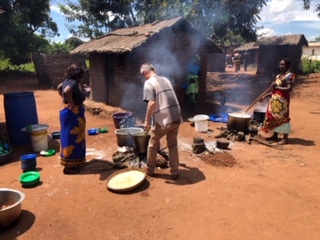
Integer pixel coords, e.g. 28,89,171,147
227,113,251,132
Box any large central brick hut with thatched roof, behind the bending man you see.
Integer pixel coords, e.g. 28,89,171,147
70,17,222,116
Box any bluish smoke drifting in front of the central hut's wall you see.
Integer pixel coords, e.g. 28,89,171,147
120,24,204,117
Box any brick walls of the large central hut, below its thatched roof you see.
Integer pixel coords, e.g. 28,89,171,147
89,31,211,115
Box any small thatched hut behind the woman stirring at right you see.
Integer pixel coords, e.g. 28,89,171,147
256,34,308,74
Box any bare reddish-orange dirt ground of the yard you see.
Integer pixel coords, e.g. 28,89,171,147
0,69,320,240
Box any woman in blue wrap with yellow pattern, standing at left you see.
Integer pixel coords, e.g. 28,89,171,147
58,64,86,174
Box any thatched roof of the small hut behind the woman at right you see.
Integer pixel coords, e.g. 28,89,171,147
256,34,308,46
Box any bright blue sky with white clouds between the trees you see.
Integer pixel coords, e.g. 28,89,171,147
51,0,320,42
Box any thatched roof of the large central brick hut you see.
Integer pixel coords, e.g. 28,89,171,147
70,17,222,54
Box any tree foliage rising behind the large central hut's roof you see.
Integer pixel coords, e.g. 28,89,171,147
60,0,268,41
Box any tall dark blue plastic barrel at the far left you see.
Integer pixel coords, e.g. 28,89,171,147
3,92,38,146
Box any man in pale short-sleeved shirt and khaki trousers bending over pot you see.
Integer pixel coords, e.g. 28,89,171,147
140,63,182,180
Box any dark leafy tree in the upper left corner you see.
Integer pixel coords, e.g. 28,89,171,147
0,0,58,65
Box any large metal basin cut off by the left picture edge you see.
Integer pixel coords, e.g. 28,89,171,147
0,188,25,228
